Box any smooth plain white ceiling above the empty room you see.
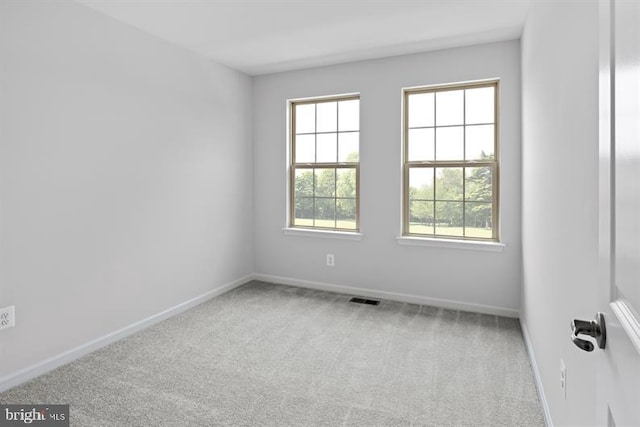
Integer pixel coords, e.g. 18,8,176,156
78,0,529,75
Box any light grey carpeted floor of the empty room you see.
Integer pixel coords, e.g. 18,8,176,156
0,282,544,426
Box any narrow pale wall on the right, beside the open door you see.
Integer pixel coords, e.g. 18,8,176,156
522,2,598,426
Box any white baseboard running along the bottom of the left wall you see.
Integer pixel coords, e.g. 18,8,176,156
0,274,254,392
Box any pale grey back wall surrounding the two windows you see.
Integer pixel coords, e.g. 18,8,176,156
253,41,521,313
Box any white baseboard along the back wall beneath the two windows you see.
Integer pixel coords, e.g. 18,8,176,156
253,274,520,318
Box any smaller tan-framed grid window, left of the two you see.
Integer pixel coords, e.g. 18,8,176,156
289,95,360,231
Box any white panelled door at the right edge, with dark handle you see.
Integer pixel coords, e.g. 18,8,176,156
592,0,640,427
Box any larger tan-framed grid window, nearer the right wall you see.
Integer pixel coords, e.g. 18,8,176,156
403,80,498,241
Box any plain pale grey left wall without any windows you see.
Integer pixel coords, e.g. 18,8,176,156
0,1,253,378
